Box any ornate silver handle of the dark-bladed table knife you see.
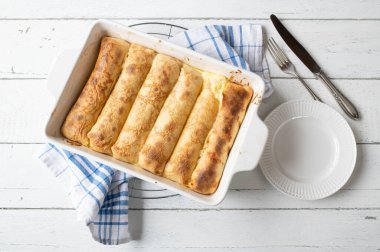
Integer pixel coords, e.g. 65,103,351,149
315,71,359,120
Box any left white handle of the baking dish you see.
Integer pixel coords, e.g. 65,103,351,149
46,49,80,100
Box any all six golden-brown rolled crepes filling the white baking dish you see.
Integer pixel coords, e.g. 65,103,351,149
61,37,253,194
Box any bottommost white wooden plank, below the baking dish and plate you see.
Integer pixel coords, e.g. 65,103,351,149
0,210,380,251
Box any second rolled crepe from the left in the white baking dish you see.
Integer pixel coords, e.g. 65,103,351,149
87,44,156,154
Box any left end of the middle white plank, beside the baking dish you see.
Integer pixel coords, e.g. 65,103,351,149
0,80,53,143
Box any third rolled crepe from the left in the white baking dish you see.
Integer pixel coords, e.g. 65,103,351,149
111,54,182,163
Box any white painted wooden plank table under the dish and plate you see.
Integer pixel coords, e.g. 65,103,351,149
0,0,380,251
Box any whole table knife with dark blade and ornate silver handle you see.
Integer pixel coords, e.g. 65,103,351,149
270,14,359,120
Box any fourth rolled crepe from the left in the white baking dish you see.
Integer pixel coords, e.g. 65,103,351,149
138,65,203,175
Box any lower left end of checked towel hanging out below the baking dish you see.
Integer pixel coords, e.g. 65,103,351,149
39,144,129,245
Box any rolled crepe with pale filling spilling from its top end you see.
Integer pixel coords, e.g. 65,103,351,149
163,73,221,184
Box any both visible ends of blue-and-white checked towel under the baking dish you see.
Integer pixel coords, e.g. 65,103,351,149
40,24,272,245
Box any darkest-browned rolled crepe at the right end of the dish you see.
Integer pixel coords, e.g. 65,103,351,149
189,82,252,194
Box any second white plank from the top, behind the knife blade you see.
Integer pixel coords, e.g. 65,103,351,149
0,19,380,79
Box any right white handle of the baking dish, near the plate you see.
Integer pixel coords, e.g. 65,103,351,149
234,114,268,173
